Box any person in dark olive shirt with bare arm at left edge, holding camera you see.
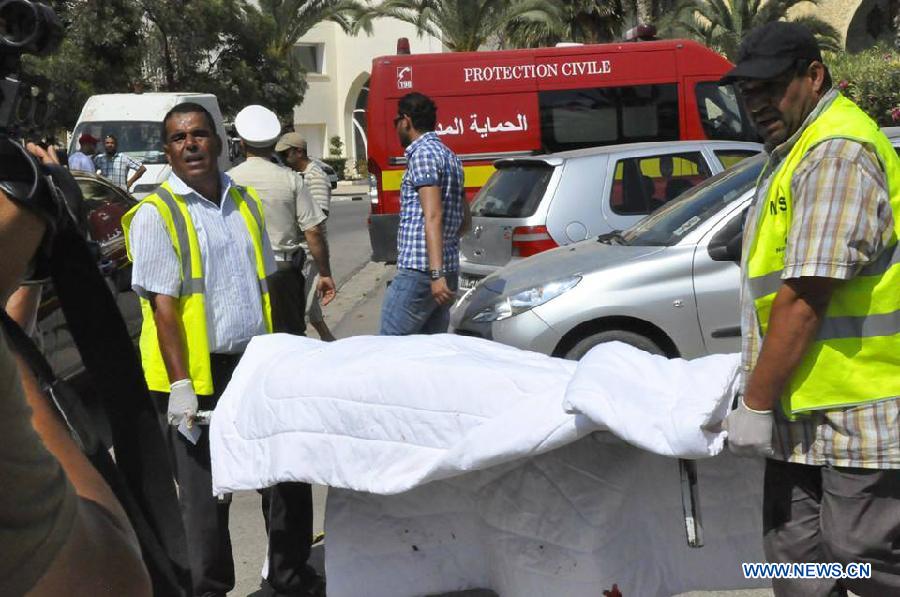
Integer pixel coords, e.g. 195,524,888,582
0,146,150,596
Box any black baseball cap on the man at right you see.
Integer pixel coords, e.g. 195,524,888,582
719,21,822,85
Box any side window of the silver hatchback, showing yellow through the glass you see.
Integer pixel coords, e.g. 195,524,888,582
610,151,710,216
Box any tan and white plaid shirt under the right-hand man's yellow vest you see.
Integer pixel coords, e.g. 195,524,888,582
741,90,900,469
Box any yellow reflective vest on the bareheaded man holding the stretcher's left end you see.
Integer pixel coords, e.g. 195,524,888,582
122,183,272,395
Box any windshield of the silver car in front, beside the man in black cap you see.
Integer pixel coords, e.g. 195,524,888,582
622,155,765,246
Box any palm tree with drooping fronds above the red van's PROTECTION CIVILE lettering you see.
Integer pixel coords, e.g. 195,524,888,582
357,0,559,52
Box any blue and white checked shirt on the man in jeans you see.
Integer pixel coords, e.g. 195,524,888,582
397,132,465,272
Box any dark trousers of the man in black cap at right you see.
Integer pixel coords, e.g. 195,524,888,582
763,460,900,597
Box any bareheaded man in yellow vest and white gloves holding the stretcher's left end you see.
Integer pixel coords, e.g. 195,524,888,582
122,103,276,597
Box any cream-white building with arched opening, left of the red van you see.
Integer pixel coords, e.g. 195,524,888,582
294,19,443,172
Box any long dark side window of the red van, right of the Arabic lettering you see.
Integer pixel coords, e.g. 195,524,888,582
538,83,679,152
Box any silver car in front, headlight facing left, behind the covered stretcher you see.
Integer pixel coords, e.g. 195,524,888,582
450,129,900,359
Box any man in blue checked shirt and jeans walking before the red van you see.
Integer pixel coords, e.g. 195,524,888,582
381,93,470,336
